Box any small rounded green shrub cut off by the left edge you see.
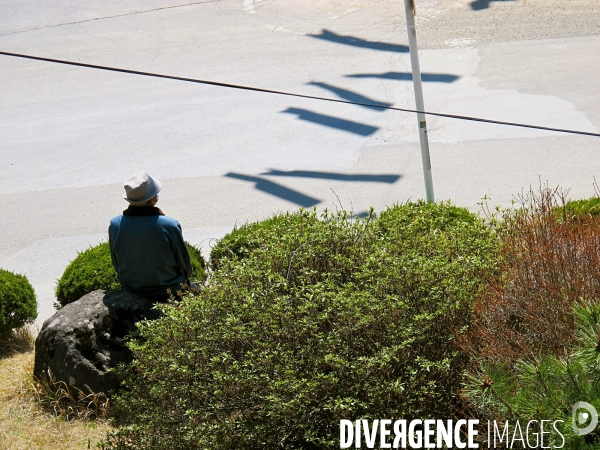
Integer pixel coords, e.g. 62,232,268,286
0,269,37,337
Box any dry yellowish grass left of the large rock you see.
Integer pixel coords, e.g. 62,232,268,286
0,330,110,450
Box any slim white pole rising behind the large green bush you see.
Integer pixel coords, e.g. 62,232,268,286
404,0,435,203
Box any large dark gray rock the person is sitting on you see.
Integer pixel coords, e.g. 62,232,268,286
33,290,160,396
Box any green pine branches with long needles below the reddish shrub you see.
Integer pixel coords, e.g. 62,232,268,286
465,303,600,450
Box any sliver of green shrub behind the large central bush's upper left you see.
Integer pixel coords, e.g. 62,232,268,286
210,213,317,269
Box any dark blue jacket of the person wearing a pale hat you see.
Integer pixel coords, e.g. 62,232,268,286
108,206,192,296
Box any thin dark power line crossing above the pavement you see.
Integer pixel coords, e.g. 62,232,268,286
0,51,600,137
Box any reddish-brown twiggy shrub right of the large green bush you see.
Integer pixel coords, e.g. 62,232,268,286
459,187,600,364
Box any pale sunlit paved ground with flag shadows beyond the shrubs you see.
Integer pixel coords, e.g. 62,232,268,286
0,0,600,322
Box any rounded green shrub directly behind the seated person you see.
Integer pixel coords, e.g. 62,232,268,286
55,242,206,307
